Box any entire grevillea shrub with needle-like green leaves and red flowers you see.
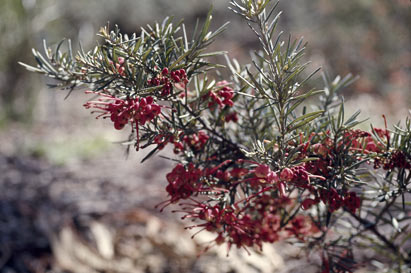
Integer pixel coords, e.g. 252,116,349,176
22,0,411,272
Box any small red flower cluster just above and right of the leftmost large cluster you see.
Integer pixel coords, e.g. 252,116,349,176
147,67,188,96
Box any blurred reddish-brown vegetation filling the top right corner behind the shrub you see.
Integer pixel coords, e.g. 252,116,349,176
285,0,411,98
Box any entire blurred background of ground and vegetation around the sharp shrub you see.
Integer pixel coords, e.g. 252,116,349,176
0,0,411,273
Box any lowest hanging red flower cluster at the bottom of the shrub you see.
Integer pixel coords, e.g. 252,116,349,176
180,191,318,249
